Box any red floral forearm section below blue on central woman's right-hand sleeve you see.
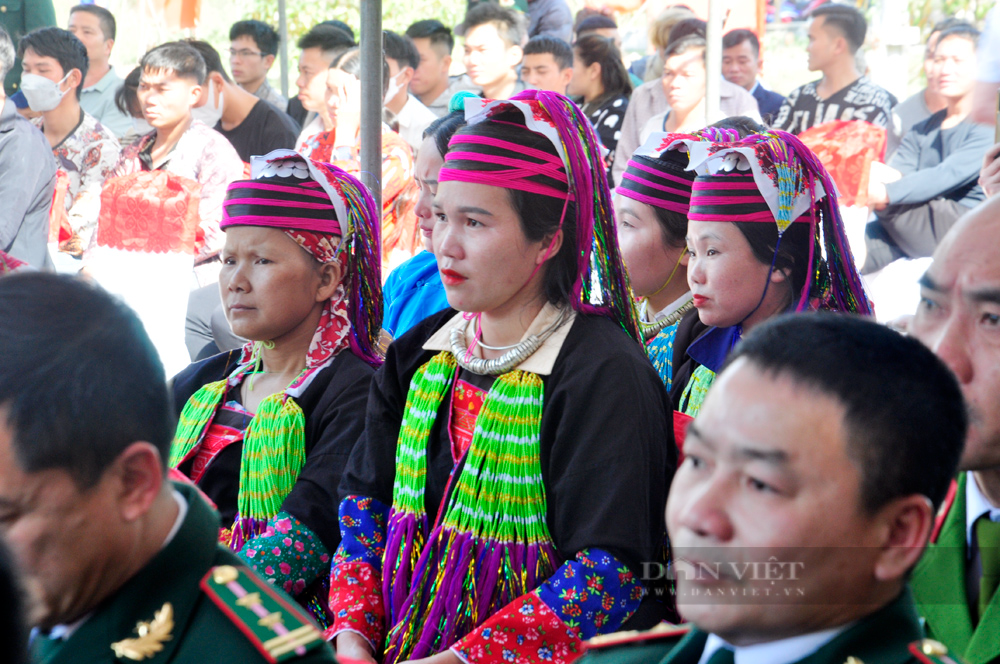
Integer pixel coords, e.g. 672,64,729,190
451,593,583,664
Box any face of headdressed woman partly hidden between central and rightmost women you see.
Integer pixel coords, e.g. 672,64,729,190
615,195,687,297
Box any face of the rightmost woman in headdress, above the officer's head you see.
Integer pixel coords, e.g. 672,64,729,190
687,221,785,327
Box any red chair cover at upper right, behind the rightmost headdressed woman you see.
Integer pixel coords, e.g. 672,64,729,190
799,120,887,206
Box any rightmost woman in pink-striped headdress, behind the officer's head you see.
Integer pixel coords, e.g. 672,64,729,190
670,131,872,419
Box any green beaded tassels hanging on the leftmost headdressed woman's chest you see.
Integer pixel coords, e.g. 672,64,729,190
170,365,306,551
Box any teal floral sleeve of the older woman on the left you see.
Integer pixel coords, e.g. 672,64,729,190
237,512,330,597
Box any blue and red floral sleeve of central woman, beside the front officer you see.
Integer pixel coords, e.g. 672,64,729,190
451,549,646,664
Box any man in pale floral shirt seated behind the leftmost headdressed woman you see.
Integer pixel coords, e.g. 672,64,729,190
105,42,243,264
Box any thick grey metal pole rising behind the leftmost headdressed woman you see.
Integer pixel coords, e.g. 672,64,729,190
359,0,382,220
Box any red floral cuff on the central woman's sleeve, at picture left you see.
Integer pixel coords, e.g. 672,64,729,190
323,562,385,652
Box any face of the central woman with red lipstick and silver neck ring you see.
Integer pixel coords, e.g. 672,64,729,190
433,180,561,315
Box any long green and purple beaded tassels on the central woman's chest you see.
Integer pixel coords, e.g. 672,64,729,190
383,352,558,664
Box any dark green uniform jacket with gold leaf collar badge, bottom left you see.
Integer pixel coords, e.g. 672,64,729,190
32,484,336,664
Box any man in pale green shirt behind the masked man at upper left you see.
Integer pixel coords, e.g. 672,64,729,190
68,5,132,138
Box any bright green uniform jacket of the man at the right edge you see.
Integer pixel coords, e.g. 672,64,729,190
910,473,1000,664
